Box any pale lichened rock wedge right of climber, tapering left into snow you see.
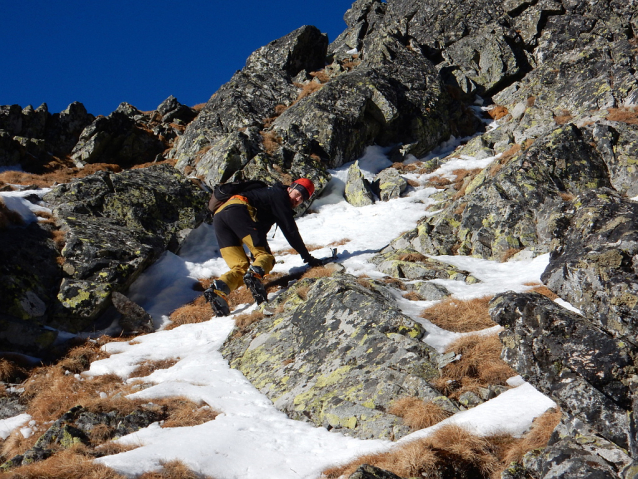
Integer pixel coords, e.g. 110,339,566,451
382,125,611,259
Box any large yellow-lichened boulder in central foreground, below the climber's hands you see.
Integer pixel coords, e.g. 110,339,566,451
222,274,441,439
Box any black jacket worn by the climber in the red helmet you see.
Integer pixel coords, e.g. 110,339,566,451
241,183,311,262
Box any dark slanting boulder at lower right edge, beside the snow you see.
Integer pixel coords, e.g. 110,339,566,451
490,292,638,458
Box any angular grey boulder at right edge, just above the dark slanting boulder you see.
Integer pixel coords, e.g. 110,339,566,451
541,190,638,338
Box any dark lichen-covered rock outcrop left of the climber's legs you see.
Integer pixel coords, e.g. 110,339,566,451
40,165,208,331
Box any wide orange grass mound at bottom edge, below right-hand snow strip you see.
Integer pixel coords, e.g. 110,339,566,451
323,425,499,479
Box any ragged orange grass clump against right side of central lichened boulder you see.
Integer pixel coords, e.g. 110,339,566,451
434,334,516,399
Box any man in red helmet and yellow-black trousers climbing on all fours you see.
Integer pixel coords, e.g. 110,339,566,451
204,178,322,316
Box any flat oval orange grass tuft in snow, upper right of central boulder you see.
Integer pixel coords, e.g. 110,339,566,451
421,296,495,333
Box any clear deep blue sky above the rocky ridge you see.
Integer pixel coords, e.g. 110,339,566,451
0,0,354,115
